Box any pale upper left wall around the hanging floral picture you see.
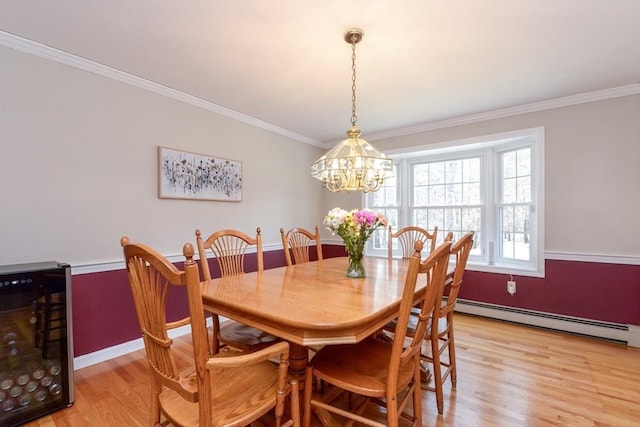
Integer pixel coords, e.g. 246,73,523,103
0,46,324,266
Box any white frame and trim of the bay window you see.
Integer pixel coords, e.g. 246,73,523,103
362,127,545,277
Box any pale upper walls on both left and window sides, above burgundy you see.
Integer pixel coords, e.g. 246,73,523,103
0,42,640,266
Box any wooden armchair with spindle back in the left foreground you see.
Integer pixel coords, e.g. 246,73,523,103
120,237,300,426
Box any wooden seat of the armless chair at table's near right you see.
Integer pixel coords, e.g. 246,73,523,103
311,338,413,397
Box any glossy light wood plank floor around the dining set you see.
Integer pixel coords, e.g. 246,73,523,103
21,314,640,427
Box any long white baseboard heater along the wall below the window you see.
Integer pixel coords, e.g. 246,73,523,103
455,298,629,343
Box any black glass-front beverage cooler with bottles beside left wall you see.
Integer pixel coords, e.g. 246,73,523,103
0,262,74,427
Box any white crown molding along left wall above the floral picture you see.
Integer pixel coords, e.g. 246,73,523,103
0,31,322,147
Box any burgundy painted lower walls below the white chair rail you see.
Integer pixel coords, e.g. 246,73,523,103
72,249,640,357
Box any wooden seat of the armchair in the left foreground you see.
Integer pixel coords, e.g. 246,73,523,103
160,361,278,427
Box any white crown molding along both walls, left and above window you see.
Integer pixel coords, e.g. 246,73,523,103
0,31,640,148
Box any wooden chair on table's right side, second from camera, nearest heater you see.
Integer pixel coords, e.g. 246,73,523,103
422,231,474,414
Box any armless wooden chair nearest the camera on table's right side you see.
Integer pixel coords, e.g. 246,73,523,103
303,241,451,427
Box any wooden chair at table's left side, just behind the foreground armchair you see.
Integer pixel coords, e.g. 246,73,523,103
196,227,280,354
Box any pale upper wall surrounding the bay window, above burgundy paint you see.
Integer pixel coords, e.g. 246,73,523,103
371,95,640,258
